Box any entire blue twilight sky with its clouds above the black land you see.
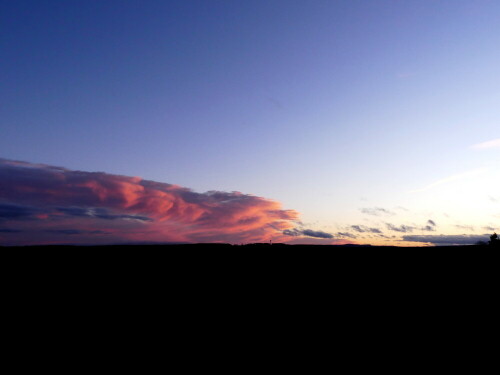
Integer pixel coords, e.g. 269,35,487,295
0,0,500,246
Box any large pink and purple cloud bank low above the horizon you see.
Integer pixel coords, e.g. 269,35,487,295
0,159,300,245
